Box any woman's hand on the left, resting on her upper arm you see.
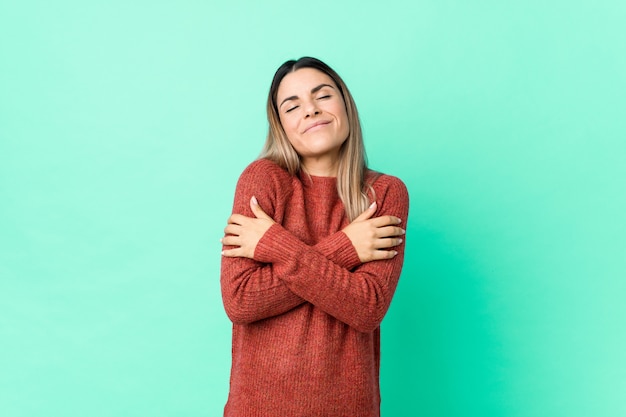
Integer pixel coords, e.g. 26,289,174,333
221,196,276,259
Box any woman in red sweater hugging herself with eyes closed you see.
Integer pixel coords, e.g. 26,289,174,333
221,57,408,417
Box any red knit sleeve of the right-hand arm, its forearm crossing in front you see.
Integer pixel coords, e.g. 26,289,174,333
255,176,409,332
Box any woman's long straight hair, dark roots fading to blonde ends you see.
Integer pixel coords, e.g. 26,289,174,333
260,57,375,221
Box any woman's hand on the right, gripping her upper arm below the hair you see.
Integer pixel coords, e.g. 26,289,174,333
342,202,405,262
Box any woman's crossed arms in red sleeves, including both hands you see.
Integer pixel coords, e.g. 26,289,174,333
221,167,408,332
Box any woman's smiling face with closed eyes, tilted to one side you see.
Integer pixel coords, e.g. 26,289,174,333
276,68,350,175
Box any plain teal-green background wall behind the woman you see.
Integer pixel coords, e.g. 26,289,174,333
0,0,626,417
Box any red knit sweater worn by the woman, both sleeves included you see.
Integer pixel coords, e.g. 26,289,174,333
221,159,408,417
